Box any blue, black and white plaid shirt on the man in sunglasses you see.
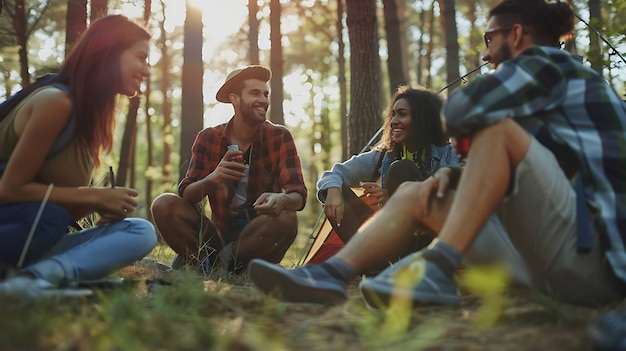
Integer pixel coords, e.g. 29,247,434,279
444,47,626,281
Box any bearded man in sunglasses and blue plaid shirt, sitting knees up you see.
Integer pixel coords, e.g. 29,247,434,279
245,0,626,314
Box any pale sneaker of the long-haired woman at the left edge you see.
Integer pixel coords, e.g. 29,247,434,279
0,276,93,299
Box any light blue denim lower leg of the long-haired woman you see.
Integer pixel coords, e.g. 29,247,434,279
24,218,157,285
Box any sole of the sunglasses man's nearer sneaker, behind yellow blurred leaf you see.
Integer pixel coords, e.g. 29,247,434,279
359,278,460,309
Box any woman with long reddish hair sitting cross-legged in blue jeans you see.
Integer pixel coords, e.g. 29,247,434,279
0,15,157,297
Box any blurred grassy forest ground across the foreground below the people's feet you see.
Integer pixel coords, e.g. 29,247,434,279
0,246,616,351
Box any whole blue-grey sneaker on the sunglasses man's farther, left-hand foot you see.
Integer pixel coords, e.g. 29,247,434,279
248,259,348,305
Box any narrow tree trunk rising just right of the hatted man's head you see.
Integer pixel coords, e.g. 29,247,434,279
270,0,285,124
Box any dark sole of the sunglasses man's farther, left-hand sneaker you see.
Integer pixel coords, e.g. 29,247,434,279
248,260,347,305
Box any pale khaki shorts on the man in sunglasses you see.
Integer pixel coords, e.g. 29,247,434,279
470,138,624,305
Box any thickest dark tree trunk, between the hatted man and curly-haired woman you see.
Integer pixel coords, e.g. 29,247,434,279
346,0,382,155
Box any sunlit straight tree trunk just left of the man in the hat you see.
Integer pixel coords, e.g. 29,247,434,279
178,1,204,179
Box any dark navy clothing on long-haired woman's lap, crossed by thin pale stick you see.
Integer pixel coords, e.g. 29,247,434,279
0,202,72,267
